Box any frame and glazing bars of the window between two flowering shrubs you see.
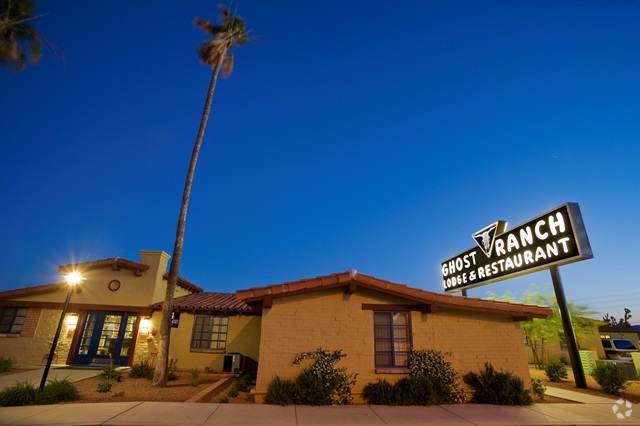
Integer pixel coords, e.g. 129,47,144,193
373,310,413,369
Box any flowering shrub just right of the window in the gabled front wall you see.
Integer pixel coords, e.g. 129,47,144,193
409,349,465,404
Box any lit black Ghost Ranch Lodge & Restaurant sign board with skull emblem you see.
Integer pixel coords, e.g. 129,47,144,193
442,203,593,292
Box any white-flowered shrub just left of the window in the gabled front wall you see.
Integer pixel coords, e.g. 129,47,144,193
293,348,358,405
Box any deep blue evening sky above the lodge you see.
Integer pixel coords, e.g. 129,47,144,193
0,0,640,323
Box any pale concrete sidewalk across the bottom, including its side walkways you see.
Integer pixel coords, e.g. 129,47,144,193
0,366,640,426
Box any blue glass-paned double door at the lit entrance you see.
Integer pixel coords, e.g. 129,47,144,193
73,311,138,365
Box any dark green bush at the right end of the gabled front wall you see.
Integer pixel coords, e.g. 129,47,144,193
462,363,533,405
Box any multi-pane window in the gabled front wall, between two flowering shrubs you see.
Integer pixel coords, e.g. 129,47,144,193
373,311,411,367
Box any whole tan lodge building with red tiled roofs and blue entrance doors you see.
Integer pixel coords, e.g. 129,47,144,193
0,251,551,402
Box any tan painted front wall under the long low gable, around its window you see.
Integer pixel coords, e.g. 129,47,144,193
256,289,530,401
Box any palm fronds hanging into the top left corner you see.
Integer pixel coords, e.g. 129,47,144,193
0,0,46,70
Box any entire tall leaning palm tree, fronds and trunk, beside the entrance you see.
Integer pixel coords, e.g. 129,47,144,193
153,6,248,387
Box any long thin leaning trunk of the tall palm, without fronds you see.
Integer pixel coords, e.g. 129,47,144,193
152,57,222,387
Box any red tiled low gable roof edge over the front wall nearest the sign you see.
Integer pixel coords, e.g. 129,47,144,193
236,269,552,318
